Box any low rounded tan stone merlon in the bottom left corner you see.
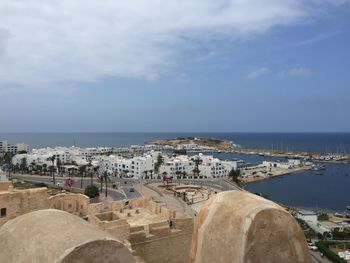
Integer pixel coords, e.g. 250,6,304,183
0,209,135,263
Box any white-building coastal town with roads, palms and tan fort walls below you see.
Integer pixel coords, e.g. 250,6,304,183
0,141,350,262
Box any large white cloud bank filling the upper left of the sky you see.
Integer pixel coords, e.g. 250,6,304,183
0,0,346,89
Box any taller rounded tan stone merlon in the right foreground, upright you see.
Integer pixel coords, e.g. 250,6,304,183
190,191,311,263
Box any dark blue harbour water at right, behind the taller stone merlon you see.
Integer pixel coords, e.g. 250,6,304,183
245,164,350,212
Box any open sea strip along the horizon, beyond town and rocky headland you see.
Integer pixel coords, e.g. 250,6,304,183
0,133,350,152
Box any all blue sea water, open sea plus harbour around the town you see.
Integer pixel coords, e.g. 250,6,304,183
0,133,350,212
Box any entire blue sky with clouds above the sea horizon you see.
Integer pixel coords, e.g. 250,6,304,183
0,0,350,132
